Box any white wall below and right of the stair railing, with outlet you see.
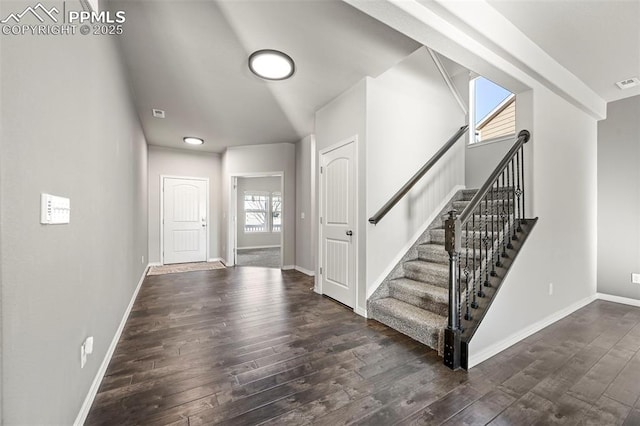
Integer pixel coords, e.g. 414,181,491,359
469,87,597,358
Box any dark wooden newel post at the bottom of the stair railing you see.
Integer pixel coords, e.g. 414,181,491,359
444,210,461,370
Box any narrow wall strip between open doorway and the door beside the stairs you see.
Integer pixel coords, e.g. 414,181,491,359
296,135,317,274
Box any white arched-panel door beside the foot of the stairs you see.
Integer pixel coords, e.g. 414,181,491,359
320,142,356,307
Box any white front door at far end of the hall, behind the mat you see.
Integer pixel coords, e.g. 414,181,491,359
163,178,207,264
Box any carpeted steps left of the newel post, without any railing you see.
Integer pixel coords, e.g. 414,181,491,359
367,190,477,355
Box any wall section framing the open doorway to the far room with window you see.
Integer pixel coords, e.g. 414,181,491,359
221,143,296,267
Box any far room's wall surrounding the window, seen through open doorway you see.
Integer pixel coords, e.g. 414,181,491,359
236,176,282,248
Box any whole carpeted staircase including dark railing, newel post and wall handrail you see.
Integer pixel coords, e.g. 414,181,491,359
367,126,537,370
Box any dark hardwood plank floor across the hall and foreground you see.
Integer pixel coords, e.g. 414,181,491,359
86,267,640,426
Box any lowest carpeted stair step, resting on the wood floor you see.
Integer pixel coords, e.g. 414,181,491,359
368,297,447,356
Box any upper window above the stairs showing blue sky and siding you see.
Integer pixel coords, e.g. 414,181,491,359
470,77,516,143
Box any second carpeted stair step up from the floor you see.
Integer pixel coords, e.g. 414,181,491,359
389,278,449,316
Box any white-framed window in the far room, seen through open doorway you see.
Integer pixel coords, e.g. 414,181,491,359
244,192,282,233
